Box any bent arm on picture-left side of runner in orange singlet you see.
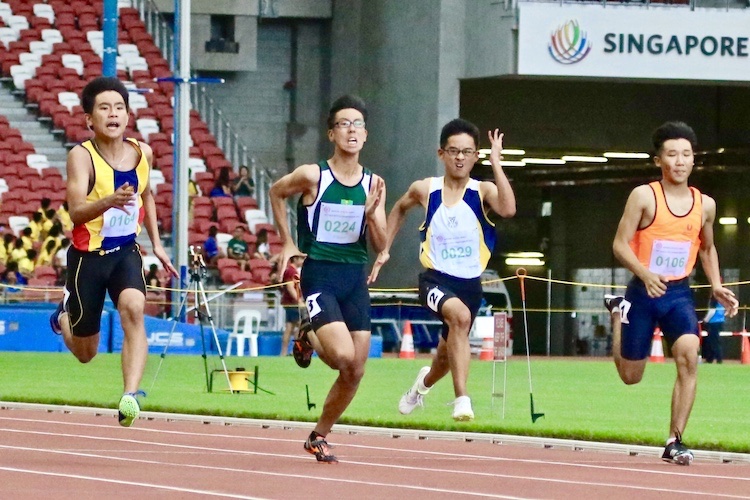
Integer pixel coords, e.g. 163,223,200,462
612,184,667,297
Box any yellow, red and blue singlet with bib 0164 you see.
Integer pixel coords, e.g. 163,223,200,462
73,139,151,252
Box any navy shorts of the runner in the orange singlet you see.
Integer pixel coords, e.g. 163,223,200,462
620,278,698,361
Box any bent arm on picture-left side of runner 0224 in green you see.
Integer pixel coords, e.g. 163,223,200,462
268,163,320,276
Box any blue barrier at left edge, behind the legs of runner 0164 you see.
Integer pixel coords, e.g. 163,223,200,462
0,303,112,352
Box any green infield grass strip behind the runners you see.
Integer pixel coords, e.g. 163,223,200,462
0,352,750,453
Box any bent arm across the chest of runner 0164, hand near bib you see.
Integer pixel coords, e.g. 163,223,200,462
66,145,135,224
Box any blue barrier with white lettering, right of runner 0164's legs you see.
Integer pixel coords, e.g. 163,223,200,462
112,311,229,354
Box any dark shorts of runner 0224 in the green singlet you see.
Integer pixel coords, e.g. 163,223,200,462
300,257,370,332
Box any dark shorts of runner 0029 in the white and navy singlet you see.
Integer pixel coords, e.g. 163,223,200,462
419,269,482,340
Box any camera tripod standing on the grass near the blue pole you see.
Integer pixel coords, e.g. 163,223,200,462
151,245,234,392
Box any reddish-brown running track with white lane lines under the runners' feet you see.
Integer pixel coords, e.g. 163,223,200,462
0,402,750,500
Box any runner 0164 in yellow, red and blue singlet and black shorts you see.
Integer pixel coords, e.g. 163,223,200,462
50,77,178,427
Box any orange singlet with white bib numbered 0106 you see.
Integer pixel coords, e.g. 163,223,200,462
630,181,703,281
